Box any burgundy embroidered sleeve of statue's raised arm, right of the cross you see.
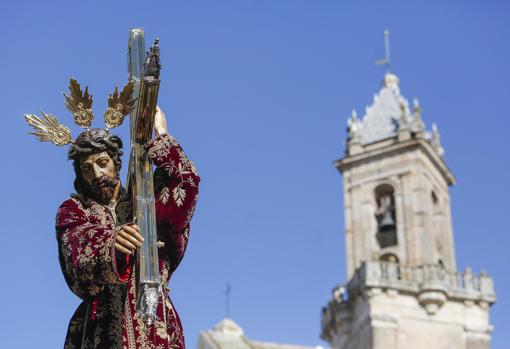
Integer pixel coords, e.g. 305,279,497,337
146,134,200,270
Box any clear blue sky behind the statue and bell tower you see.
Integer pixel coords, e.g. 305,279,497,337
0,0,510,349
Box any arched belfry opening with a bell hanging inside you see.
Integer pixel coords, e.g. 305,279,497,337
375,184,397,248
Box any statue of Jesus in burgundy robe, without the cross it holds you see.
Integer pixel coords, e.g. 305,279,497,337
26,96,200,349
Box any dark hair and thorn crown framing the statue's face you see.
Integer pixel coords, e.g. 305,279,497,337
67,128,123,195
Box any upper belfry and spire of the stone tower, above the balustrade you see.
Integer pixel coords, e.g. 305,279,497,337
336,73,456,277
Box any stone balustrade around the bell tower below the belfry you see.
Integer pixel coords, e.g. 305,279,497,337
321,261,496,340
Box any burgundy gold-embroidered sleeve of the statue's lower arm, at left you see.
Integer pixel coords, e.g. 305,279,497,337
56,199,130,298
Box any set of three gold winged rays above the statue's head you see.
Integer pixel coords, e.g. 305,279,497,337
25,79,135,146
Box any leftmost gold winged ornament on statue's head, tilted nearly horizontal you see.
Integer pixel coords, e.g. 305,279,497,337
25,110,73,146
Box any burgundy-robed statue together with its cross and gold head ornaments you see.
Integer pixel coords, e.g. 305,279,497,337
25,30,200,349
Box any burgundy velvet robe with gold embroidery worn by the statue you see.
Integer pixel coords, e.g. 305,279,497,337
56,135,200,349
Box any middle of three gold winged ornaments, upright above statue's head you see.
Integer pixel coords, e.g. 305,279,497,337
63,79,94,128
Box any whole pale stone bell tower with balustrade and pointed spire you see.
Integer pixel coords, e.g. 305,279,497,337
321,71,495,349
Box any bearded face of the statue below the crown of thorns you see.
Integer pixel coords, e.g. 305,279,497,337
80,151,120,204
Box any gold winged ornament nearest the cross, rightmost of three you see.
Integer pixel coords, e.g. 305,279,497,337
104,81,135,128
